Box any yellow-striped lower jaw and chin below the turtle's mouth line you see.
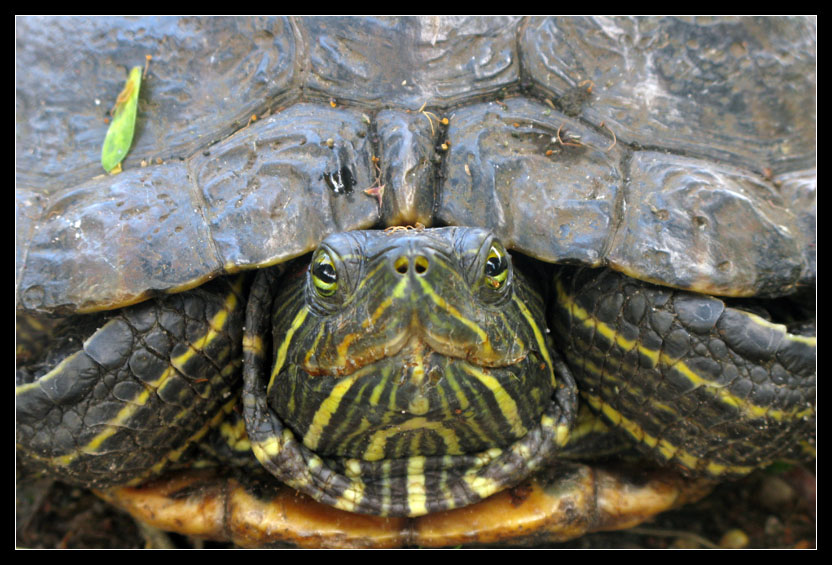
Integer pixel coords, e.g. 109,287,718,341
268,334,553,462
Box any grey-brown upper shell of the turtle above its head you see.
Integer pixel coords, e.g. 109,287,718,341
15,18,816,543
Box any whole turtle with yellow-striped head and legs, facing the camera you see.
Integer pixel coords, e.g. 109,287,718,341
15,17,816,547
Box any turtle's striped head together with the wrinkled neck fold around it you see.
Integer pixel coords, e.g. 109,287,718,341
245,228,574,515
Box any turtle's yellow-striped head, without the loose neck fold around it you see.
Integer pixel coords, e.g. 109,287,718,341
268,228,554,461
